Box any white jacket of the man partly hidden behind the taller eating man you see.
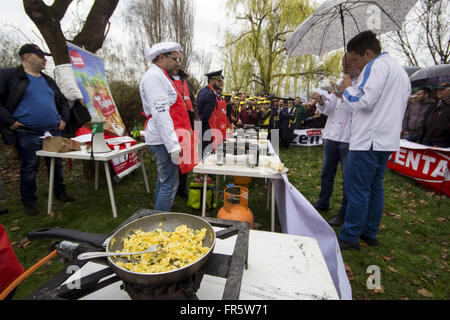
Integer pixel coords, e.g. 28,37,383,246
317,79,357,143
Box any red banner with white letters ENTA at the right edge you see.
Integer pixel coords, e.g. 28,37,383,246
388,140,450,197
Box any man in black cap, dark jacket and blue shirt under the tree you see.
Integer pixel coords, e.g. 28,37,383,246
0,44,75,215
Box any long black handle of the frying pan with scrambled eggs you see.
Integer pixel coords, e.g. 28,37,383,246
28,228,108,248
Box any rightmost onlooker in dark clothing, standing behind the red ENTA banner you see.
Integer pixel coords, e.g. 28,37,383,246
423,83,450,148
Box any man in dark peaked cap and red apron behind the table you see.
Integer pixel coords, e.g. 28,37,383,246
197,70,227,156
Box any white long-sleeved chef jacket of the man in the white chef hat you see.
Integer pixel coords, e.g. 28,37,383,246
139,64,181,153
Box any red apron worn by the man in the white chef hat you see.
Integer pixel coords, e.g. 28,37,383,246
144,68,200,174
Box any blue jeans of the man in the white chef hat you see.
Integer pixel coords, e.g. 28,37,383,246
148,145,179,212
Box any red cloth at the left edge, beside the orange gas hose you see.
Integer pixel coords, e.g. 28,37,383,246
0,224,25,292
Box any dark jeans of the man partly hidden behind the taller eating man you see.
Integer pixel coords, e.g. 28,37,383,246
317,139,349,217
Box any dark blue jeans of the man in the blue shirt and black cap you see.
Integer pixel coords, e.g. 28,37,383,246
16,128,66,206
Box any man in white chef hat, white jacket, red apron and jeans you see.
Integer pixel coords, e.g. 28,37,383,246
139,42,198,212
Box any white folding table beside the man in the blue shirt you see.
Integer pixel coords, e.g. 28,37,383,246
36,143,150,218
